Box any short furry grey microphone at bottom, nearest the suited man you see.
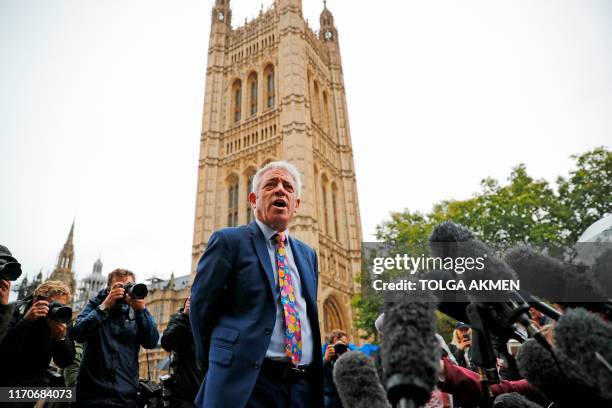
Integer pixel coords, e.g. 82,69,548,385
333,351,391,408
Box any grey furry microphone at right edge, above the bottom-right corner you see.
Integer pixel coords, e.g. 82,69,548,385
554,308,612,400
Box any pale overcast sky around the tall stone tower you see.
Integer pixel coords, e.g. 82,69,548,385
0,0,612,286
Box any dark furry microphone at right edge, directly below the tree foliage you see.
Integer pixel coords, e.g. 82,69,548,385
504,246,612,317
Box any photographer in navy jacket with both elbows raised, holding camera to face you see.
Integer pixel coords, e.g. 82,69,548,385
72,269,159,408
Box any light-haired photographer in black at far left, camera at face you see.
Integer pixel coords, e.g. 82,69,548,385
0,281,75,387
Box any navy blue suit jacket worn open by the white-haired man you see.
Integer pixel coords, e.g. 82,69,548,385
190,222,323,408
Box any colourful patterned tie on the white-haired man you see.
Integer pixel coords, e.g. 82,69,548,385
272,232,302,367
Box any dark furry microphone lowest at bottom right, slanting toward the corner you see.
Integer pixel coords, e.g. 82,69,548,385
516,339,607,408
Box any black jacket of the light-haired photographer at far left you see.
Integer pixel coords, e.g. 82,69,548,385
0,301,75,387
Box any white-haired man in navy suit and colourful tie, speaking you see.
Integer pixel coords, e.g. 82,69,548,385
190,162,323,408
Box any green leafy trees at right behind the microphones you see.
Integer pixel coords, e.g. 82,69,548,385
353,147,612,335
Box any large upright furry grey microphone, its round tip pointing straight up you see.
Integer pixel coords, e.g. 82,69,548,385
382,292,441,408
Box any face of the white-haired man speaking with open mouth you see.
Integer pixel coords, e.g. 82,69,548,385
249,169,300,232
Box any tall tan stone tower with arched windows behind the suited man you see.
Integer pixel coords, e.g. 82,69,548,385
192,0,362,340
